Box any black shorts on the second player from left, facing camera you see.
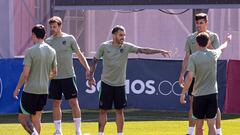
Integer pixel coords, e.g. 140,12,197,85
48,77,78,100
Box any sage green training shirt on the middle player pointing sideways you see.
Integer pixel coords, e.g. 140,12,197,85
95,41,139,86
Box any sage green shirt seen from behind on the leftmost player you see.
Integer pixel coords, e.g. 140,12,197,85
23,42,57,94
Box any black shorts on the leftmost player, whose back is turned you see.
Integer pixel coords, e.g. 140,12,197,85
19,92,48,115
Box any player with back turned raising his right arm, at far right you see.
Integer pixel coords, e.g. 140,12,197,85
180,32,232,135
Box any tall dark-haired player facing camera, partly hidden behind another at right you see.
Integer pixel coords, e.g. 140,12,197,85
179,13,221,135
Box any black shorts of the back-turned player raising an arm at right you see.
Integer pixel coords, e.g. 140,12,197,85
193,94,218,119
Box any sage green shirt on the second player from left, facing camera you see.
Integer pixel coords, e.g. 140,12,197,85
46,33,80,79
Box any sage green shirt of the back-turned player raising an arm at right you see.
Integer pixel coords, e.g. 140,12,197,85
187,49,222,96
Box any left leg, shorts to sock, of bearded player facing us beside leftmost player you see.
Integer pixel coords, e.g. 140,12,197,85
48,79,62,135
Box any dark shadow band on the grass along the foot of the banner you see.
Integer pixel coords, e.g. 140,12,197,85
0,109,240,124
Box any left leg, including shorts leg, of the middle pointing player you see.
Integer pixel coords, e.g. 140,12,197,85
98,82,114,135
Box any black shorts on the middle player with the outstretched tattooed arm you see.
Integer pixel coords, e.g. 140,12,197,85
99,82,127,110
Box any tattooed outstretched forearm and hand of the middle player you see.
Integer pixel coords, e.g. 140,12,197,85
138,48,171,57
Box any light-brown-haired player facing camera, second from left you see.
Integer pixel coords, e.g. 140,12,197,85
46,16,90,135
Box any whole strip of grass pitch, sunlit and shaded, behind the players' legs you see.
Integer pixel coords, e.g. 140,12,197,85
0,110,240,135
